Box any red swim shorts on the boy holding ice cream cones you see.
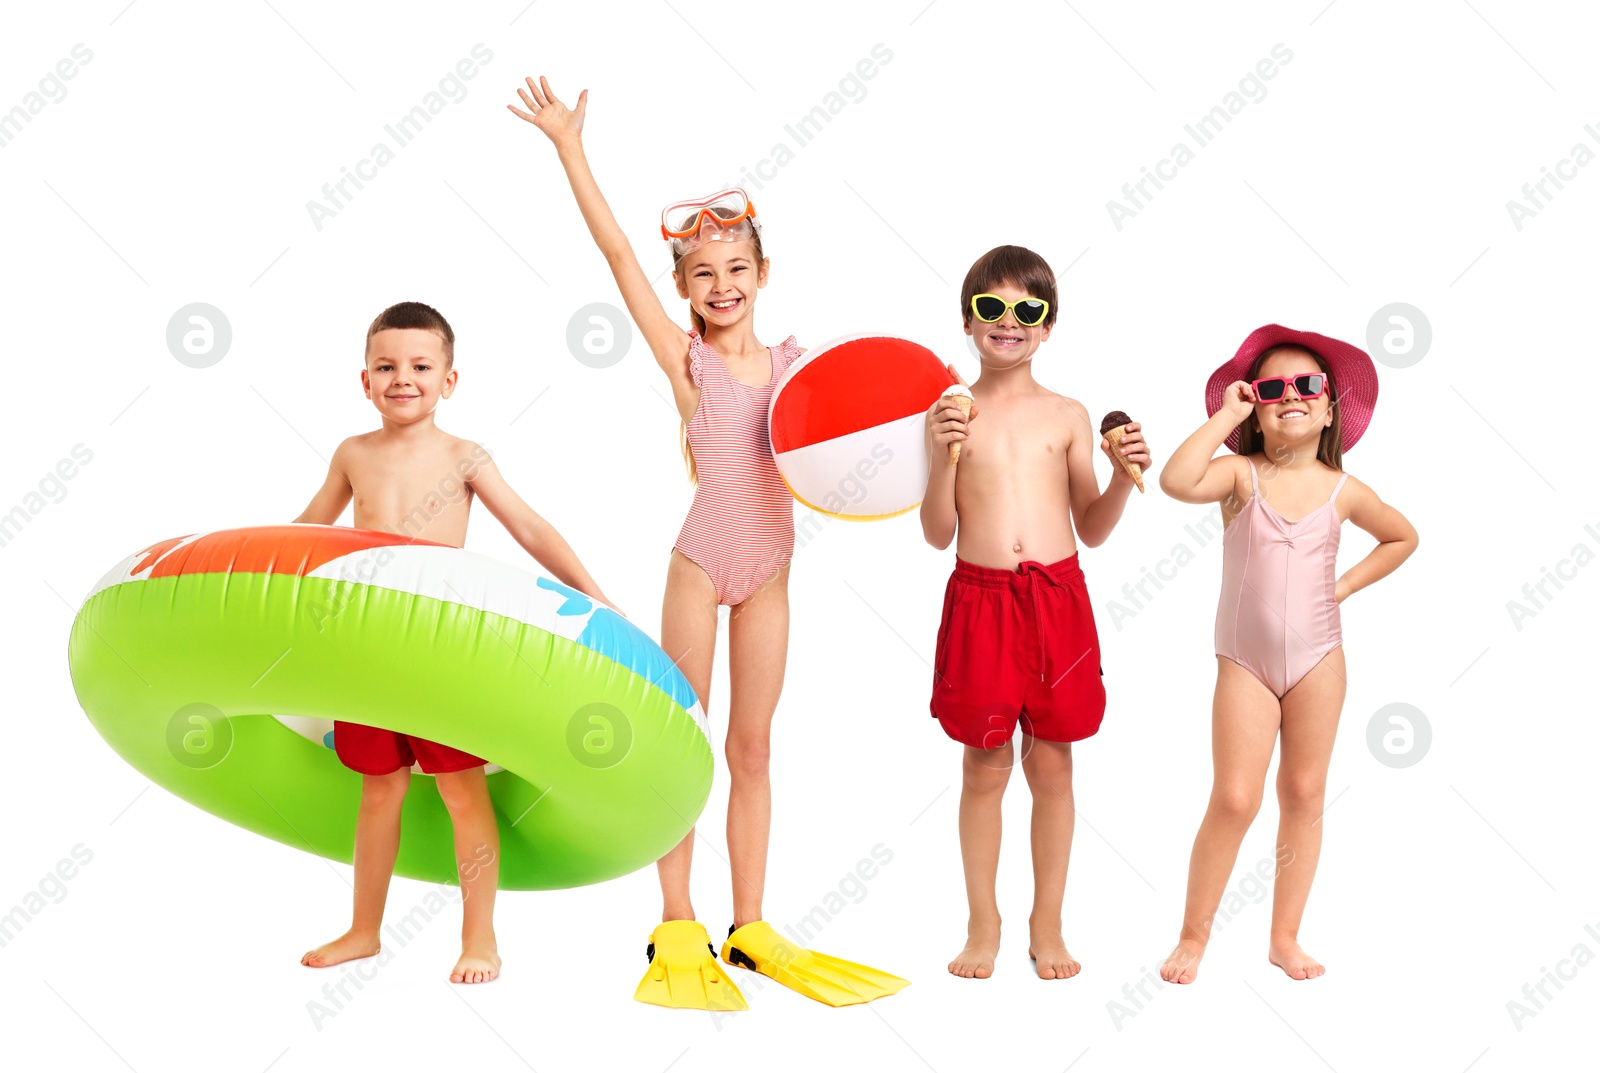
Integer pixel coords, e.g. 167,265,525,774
928,552,1106,748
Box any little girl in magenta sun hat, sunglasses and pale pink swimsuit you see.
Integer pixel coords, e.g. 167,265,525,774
1162,325,1418,983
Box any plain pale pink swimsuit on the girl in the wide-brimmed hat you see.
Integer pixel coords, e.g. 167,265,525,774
1216,459,1347,699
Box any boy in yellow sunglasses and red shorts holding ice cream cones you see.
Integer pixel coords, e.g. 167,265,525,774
922,246,1150,980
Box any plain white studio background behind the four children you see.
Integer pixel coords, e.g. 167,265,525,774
0,0,1600,1071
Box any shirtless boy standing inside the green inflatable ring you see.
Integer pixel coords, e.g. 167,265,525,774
294,302,610,983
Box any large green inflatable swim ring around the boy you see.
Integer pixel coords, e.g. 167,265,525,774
67,525,712,891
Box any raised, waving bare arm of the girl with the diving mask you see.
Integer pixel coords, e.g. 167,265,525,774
506,75,698,416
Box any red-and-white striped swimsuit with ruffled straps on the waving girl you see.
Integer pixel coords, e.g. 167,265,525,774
675,329,800,606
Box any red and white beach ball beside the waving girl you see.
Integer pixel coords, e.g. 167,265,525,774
768,336,955,521
